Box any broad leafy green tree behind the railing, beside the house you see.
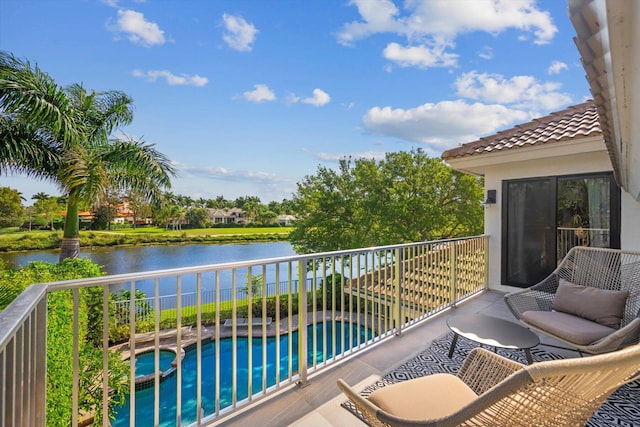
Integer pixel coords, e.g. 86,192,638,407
291,149,484,253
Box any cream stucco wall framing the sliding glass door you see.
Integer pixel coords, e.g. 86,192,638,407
484,151,612,291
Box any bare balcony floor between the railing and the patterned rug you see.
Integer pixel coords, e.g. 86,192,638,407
216,291,577,427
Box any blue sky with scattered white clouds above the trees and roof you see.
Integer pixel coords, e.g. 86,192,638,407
0,0,590,204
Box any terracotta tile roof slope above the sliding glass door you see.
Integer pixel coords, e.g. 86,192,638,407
442,100,602,160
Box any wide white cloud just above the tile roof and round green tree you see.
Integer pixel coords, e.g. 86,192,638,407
363,100,531,151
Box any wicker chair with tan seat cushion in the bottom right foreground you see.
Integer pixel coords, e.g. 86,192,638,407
338,345,640,427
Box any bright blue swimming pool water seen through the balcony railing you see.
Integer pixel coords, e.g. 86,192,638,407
112,322,372,427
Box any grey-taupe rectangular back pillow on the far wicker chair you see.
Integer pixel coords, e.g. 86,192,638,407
553,279,629,328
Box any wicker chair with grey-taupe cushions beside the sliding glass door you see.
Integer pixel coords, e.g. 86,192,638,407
505,246,640,354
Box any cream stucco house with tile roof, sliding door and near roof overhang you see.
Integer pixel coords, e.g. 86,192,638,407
442,0,640,291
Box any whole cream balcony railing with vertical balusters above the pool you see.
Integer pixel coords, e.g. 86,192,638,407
0,236,488,427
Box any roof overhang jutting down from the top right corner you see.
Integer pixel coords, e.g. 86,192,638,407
568,0,640,200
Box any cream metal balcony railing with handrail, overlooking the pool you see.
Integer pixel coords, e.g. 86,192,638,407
0,235,488,427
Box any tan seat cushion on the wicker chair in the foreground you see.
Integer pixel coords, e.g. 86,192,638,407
369,374,477,420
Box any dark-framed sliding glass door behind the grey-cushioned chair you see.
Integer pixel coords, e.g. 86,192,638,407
502,173,620,287
